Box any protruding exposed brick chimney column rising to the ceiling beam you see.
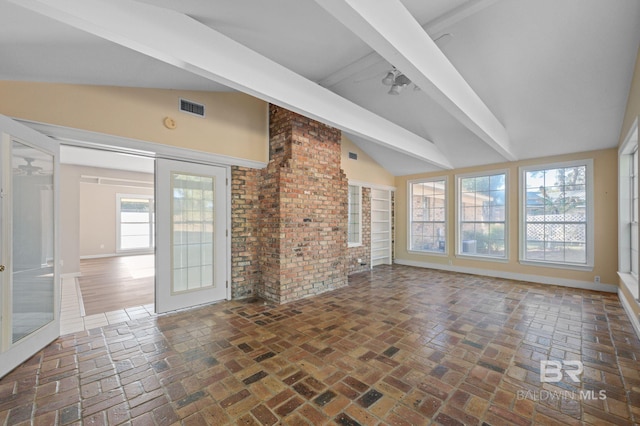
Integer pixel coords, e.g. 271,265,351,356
258,105,348,303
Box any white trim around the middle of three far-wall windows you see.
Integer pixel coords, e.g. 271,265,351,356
455,169,511,263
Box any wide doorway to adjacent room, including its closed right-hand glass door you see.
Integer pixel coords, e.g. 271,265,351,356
56,146,231,334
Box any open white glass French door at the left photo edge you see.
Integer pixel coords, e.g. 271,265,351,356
0,116,60,377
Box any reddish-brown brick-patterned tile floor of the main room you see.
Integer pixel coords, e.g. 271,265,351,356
0,266,640,425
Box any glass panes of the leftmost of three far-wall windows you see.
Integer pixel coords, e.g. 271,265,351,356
409,178,447,253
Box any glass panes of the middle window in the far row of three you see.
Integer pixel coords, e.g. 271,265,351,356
457,172,507,259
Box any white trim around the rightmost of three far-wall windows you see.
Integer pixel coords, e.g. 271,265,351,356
518,158,595,271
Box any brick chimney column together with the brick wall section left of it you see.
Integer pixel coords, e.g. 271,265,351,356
231,105,350,303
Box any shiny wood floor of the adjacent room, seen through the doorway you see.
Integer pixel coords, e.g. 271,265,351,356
78,255,155,315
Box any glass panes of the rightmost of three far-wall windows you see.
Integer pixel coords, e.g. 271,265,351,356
520,161,593,267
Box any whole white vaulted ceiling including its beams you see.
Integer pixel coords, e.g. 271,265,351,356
0,0,640,175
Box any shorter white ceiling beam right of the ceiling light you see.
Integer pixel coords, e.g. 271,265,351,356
316,0,517,161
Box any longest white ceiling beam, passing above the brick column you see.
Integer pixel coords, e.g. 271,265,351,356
10,0,452,169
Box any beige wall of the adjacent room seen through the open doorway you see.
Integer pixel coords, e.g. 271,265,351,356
60,164,153,274
